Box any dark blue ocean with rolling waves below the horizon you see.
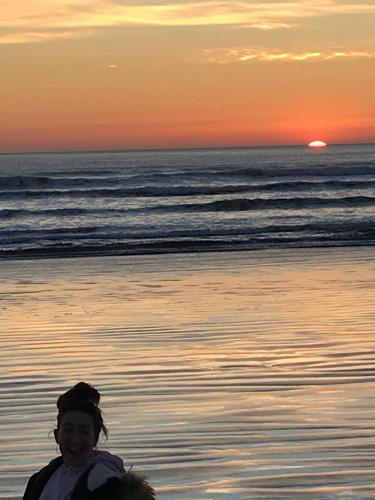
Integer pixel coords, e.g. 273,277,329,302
0,145,375,258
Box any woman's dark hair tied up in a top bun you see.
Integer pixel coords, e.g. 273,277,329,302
57,382,108,440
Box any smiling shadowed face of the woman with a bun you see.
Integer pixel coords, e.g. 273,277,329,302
55,410,97,467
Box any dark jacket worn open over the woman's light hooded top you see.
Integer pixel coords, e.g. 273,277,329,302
23,457,122,500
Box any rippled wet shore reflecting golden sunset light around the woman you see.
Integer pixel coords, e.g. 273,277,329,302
0,248,375,500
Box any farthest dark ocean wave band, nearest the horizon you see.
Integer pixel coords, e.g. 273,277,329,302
0,160,375,191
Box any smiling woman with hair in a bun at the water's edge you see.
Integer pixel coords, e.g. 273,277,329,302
23,382,155,500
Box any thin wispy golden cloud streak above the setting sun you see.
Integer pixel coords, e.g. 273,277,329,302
200,47,375,64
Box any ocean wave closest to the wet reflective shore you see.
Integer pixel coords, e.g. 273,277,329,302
0,220,375,253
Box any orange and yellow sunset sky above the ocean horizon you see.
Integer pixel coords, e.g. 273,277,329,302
0,0,375,152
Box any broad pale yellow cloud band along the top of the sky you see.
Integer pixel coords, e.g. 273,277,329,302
0,0,375,43
